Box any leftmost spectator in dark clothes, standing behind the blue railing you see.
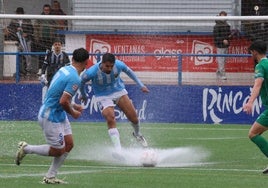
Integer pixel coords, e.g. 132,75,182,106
5,7,34,75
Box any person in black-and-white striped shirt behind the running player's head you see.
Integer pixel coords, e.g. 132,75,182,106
41,38,70,86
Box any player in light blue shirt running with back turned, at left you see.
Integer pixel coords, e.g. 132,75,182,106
15,48,89,184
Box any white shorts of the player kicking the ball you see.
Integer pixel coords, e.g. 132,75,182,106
96,89,128,111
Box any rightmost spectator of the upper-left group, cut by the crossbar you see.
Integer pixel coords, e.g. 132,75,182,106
51,1,68,43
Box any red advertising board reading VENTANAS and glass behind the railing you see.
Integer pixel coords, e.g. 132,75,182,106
86,34,253,72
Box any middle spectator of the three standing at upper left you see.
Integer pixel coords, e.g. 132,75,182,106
34,4,56,75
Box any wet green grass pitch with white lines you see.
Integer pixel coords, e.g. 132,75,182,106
0,121,268,188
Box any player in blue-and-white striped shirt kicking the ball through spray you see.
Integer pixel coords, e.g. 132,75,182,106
80,53,149,152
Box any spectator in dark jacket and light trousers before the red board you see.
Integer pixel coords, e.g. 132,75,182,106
213,11,231,80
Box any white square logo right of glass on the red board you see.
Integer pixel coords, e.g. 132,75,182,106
191,40,213,65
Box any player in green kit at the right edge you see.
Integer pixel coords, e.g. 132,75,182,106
243,40,268,174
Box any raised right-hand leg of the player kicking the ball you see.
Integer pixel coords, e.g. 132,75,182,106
117,95,148,147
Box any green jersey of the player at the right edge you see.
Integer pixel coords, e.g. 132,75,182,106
255,58,268,108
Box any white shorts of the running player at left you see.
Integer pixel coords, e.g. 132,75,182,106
38,116,72,149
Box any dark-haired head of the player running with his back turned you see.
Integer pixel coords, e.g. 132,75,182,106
72,48,89,73
